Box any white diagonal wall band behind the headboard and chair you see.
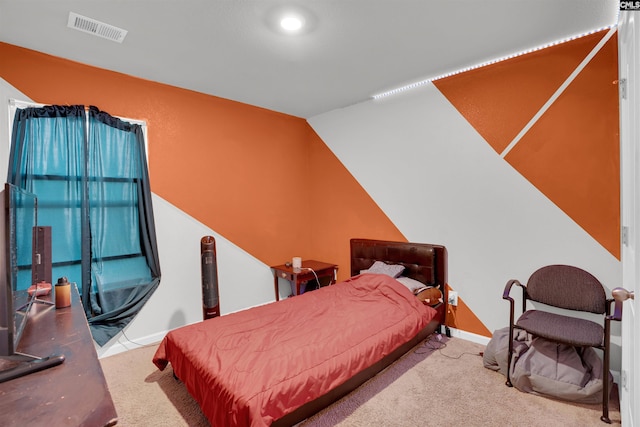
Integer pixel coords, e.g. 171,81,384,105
309,85,621,369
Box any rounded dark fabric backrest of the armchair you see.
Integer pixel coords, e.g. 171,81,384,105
527,265,607,314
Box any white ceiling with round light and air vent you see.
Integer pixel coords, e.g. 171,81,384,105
0,0,619,118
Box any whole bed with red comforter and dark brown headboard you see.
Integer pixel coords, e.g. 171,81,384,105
153,239,447,426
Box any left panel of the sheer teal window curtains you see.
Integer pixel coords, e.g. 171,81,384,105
7,105,88,294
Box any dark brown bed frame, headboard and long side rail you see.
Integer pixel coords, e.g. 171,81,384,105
272,239,447,427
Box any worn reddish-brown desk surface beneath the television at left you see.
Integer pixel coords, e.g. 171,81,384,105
0,287,117,427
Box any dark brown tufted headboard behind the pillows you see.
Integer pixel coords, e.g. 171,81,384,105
351,239,447,292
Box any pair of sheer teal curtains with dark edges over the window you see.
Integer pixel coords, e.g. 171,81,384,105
8,105,160,345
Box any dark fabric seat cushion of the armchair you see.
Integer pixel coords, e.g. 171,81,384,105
516,310,604,348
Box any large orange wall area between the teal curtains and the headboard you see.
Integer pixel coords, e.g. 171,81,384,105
0,43,405,279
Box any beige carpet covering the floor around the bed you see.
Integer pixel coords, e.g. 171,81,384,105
101,338,620,427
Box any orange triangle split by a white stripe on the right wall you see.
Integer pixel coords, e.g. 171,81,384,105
435,31,620,259
